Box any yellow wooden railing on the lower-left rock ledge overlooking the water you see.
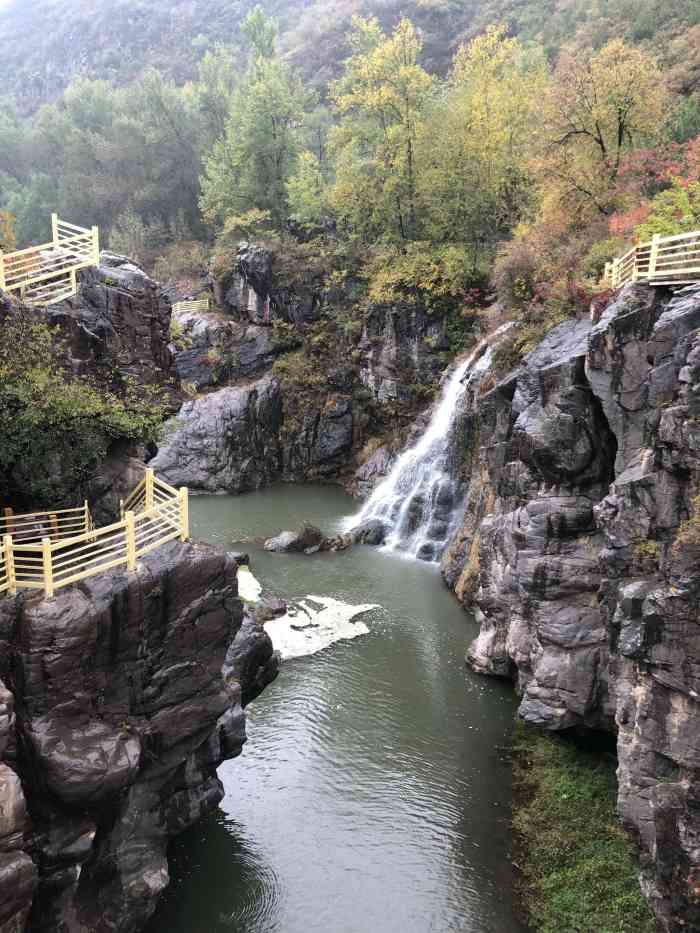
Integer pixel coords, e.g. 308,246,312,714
0,470,190,599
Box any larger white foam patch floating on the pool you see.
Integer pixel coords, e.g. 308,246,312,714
265,596,381,660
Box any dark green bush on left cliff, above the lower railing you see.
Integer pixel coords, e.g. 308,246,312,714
0,309,164,507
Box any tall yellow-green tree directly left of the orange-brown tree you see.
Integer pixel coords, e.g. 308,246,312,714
419,26,547,265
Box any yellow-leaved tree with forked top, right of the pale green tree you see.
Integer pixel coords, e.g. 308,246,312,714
329,17,434,241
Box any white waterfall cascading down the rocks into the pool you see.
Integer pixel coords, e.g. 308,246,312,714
352,341,493,561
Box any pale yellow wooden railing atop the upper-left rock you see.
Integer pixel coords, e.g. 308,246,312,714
0,214,100,305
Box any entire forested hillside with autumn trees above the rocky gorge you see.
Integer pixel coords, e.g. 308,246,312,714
0,0,700,370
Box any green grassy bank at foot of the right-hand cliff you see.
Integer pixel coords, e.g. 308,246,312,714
514,725,656,933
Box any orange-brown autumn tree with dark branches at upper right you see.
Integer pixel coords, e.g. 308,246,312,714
540,39,669,220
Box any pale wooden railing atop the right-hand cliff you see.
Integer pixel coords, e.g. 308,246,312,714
602,230,700,289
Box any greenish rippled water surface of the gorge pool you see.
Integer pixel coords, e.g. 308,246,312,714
150,487,522,933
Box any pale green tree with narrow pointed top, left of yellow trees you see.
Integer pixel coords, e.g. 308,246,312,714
200,8,313,226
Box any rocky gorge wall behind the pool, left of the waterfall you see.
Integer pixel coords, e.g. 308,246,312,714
150,244,449,493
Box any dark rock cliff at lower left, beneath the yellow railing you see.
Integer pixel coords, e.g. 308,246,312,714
0,544,278,933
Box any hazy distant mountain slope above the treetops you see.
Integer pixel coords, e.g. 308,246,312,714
0,0,700,112
